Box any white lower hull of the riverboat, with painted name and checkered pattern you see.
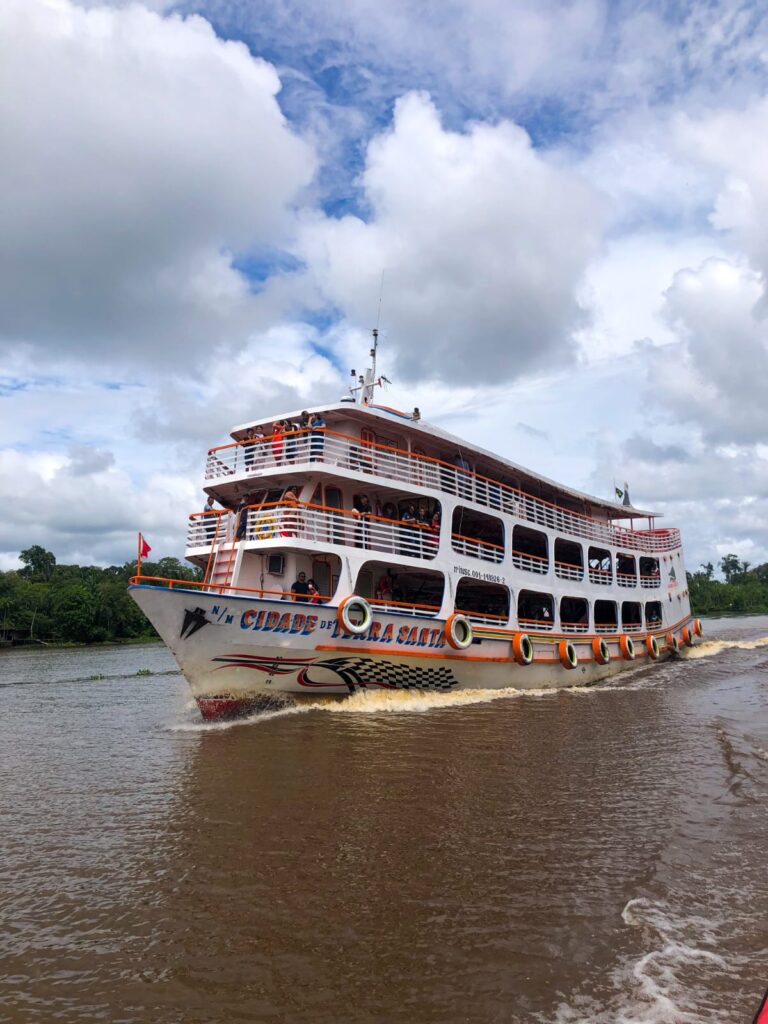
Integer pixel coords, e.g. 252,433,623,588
130,585,688,719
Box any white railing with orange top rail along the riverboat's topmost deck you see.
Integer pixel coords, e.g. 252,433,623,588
206,428,680,552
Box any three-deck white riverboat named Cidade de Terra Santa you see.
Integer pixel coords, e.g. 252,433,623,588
130,341,701,720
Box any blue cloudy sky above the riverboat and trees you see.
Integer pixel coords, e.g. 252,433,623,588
0,0,768,569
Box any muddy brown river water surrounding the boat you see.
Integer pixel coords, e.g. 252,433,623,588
0,617,768,1024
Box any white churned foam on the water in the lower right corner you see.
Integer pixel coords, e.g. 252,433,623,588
553,897,736,1024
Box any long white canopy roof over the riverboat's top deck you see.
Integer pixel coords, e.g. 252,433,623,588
229,399,662,520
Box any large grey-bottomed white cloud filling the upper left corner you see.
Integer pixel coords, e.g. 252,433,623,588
0,0,315,364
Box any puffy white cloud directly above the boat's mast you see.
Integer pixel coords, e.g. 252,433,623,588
301,94,601,382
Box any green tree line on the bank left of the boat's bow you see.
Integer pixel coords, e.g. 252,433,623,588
0,545,201,643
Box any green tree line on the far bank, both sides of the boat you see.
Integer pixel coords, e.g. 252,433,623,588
0,544,768,643
